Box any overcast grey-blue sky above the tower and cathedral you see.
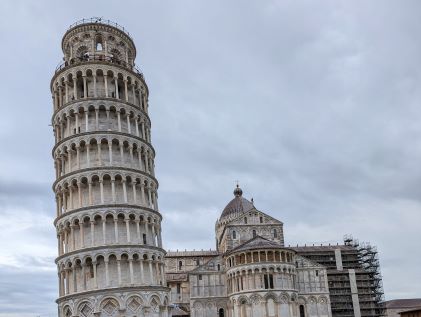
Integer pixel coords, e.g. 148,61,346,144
0,0,421,317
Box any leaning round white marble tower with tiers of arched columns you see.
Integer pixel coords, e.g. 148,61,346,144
51,19,169,317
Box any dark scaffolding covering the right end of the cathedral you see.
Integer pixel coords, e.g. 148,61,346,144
294,235,385,317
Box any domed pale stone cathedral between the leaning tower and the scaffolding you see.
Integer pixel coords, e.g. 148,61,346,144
165,186,332,317
